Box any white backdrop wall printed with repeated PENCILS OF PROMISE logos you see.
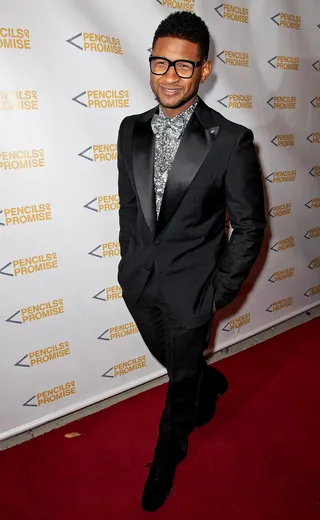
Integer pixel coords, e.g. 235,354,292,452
0,0,320,439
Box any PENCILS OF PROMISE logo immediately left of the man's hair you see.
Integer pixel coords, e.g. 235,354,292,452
66,32,123,54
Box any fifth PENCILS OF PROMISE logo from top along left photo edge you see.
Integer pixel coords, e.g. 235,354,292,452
0,253,58,276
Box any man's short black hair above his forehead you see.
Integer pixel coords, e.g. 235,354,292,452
152,11,210,61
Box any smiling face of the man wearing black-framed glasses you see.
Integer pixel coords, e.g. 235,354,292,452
150,37,211,109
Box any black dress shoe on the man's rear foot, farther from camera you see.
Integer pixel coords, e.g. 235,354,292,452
195,365,229,427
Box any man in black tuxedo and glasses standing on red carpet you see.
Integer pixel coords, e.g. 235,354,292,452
118,12,265,511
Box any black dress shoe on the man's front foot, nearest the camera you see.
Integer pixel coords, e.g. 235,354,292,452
141,440,188,512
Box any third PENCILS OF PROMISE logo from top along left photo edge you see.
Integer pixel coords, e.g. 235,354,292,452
0,148,45,171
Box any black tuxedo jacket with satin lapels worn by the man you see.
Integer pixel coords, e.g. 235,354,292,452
118,96,266,328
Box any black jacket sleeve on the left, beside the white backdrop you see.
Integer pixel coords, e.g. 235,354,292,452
118,119,137,256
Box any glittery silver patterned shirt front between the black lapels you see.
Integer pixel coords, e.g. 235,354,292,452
154,97,198,218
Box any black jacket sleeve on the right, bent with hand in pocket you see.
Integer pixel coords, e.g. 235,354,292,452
213,129,266,310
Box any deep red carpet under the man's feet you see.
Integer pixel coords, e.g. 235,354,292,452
0,318,320,520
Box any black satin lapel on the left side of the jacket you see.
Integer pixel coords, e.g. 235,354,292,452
133,121,157,234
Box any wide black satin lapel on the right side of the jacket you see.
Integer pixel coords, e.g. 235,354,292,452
156,115,215,234
